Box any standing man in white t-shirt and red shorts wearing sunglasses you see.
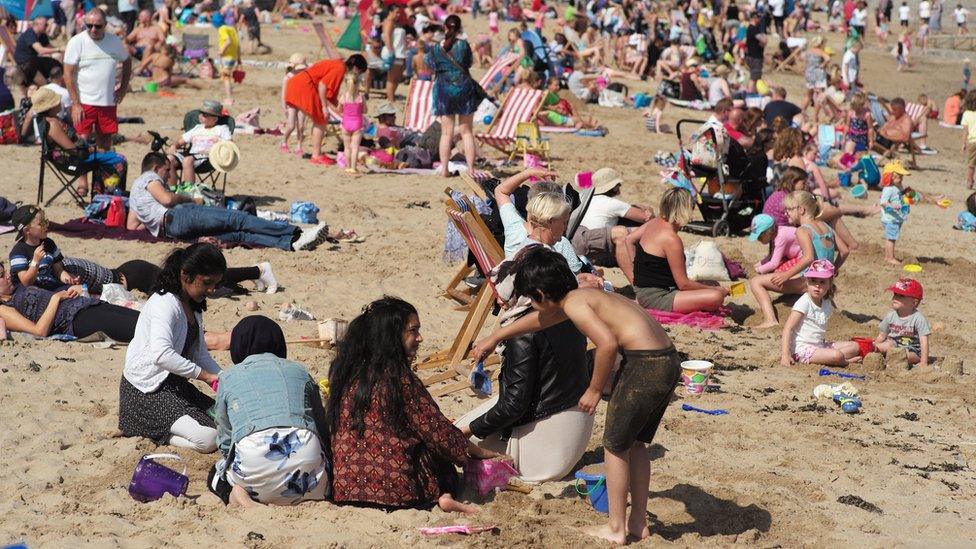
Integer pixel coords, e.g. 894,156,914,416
64,8,132,151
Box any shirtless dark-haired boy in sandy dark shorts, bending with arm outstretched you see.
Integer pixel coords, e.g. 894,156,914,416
472,247,680,544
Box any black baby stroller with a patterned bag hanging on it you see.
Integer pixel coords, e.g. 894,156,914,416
675,119,762,237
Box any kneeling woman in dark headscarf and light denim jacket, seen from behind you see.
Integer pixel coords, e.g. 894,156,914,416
208,316,331,507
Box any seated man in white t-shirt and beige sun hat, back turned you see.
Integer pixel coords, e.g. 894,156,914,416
573,168,654,267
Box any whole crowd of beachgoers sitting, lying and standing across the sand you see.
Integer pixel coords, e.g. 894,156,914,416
0,0,976,543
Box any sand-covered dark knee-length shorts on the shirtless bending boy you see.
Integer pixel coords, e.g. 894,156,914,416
603,347,681,452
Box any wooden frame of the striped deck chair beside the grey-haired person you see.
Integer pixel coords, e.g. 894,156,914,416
418,191,505,371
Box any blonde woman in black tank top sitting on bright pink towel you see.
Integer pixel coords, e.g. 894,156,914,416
624,187,729,313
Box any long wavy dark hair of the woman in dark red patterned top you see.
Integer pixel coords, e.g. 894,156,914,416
326,296,417,434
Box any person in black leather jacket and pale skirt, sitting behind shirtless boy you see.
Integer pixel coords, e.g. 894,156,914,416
455,316,593,482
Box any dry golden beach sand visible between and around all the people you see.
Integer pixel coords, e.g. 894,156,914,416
0,13,976,547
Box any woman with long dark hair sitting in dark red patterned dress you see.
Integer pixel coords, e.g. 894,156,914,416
326,297,508,513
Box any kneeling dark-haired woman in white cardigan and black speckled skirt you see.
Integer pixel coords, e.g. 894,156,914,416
119,244,227,453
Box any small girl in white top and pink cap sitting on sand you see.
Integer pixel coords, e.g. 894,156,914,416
780,259,861,366
